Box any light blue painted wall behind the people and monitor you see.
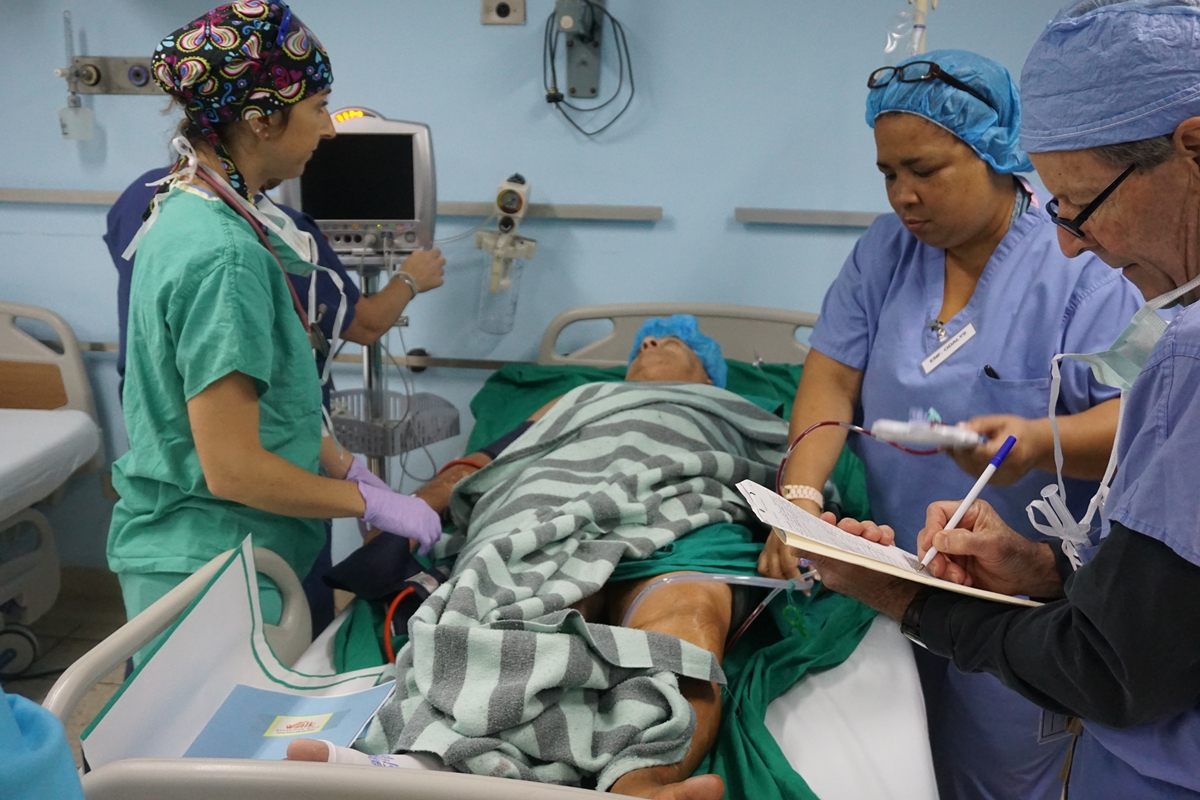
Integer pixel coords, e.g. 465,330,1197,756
0,0,1058,565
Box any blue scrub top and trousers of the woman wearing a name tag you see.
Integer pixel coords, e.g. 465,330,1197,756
810,194,1142,800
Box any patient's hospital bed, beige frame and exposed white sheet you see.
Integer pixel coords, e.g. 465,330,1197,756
44,303,937,800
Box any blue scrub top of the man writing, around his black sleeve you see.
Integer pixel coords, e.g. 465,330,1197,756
1070,305,1200,798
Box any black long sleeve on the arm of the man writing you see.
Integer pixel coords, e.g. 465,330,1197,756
920,523,1200,728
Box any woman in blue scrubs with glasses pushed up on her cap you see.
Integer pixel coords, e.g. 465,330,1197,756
760,50,1140,800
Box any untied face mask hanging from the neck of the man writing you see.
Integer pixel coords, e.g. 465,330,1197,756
1025,277,1200,569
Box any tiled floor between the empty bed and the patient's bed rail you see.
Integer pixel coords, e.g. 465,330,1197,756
4,567,125,763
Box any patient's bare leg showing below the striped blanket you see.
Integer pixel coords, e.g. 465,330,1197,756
605,576,732,800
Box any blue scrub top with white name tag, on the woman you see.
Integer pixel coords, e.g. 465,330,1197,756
810,205,1142,552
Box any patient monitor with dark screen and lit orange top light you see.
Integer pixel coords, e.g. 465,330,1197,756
281,107,438,259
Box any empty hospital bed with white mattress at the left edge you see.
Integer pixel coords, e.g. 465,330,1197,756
0,302,103,676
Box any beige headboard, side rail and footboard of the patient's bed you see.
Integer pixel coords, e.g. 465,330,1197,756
43,303,936,800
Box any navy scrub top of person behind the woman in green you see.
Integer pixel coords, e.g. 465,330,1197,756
104,167,359,408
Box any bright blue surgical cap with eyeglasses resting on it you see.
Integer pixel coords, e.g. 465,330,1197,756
866,50,1033,173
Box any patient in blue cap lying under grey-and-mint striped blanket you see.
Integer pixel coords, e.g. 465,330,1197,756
289,318,786,800
